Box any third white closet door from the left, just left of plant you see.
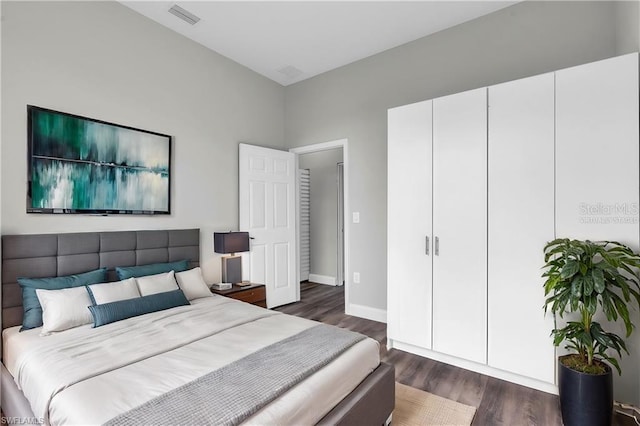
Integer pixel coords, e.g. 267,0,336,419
487,73,555,383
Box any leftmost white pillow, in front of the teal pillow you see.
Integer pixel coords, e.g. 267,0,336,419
36,286,93,336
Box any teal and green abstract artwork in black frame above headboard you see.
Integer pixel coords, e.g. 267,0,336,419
27,106,171,214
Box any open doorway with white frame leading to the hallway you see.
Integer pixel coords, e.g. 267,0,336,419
290,139,350,308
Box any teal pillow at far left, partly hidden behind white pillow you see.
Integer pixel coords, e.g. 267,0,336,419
18,268,107,331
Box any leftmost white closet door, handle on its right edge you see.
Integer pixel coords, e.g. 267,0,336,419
387,101,432,348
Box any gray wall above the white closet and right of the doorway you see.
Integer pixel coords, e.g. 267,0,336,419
285,1,640,404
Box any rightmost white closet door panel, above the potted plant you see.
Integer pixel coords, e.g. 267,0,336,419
556,53,639,249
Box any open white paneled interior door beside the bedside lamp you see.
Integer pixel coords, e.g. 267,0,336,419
239,144,298,308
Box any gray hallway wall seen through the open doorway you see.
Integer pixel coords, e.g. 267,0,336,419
298,149,342,278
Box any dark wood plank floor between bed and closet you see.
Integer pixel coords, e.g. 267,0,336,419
276,283,562,426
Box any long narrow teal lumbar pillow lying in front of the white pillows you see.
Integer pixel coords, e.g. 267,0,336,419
89,290,190,327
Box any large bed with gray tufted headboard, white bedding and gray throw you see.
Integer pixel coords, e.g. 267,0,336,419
1,229,394,425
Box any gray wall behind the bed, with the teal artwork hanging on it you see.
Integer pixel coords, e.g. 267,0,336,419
0,1,284,282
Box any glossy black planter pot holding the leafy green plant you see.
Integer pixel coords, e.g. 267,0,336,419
558,357,613,426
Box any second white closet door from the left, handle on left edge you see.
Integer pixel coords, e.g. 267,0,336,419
433,88,487,363
